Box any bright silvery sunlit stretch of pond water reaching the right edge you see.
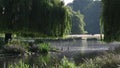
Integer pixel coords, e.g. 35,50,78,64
51,39,120,53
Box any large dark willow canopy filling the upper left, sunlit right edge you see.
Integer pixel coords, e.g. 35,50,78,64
0,0,71,36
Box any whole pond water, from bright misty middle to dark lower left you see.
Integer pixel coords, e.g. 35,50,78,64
0,39,120,68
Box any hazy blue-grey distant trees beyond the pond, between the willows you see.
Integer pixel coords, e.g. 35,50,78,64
69,0,102,34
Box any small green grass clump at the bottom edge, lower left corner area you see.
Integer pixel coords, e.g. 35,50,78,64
8,61,30,68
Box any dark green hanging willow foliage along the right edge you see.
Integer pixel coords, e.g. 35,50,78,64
101,0,120,42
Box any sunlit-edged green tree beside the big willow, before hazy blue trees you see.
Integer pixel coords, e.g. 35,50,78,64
68,7,86,34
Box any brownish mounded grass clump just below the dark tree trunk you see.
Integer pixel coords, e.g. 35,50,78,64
2,41,28,55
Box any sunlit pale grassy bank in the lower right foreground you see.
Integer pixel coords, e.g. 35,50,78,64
51,47,120,68
